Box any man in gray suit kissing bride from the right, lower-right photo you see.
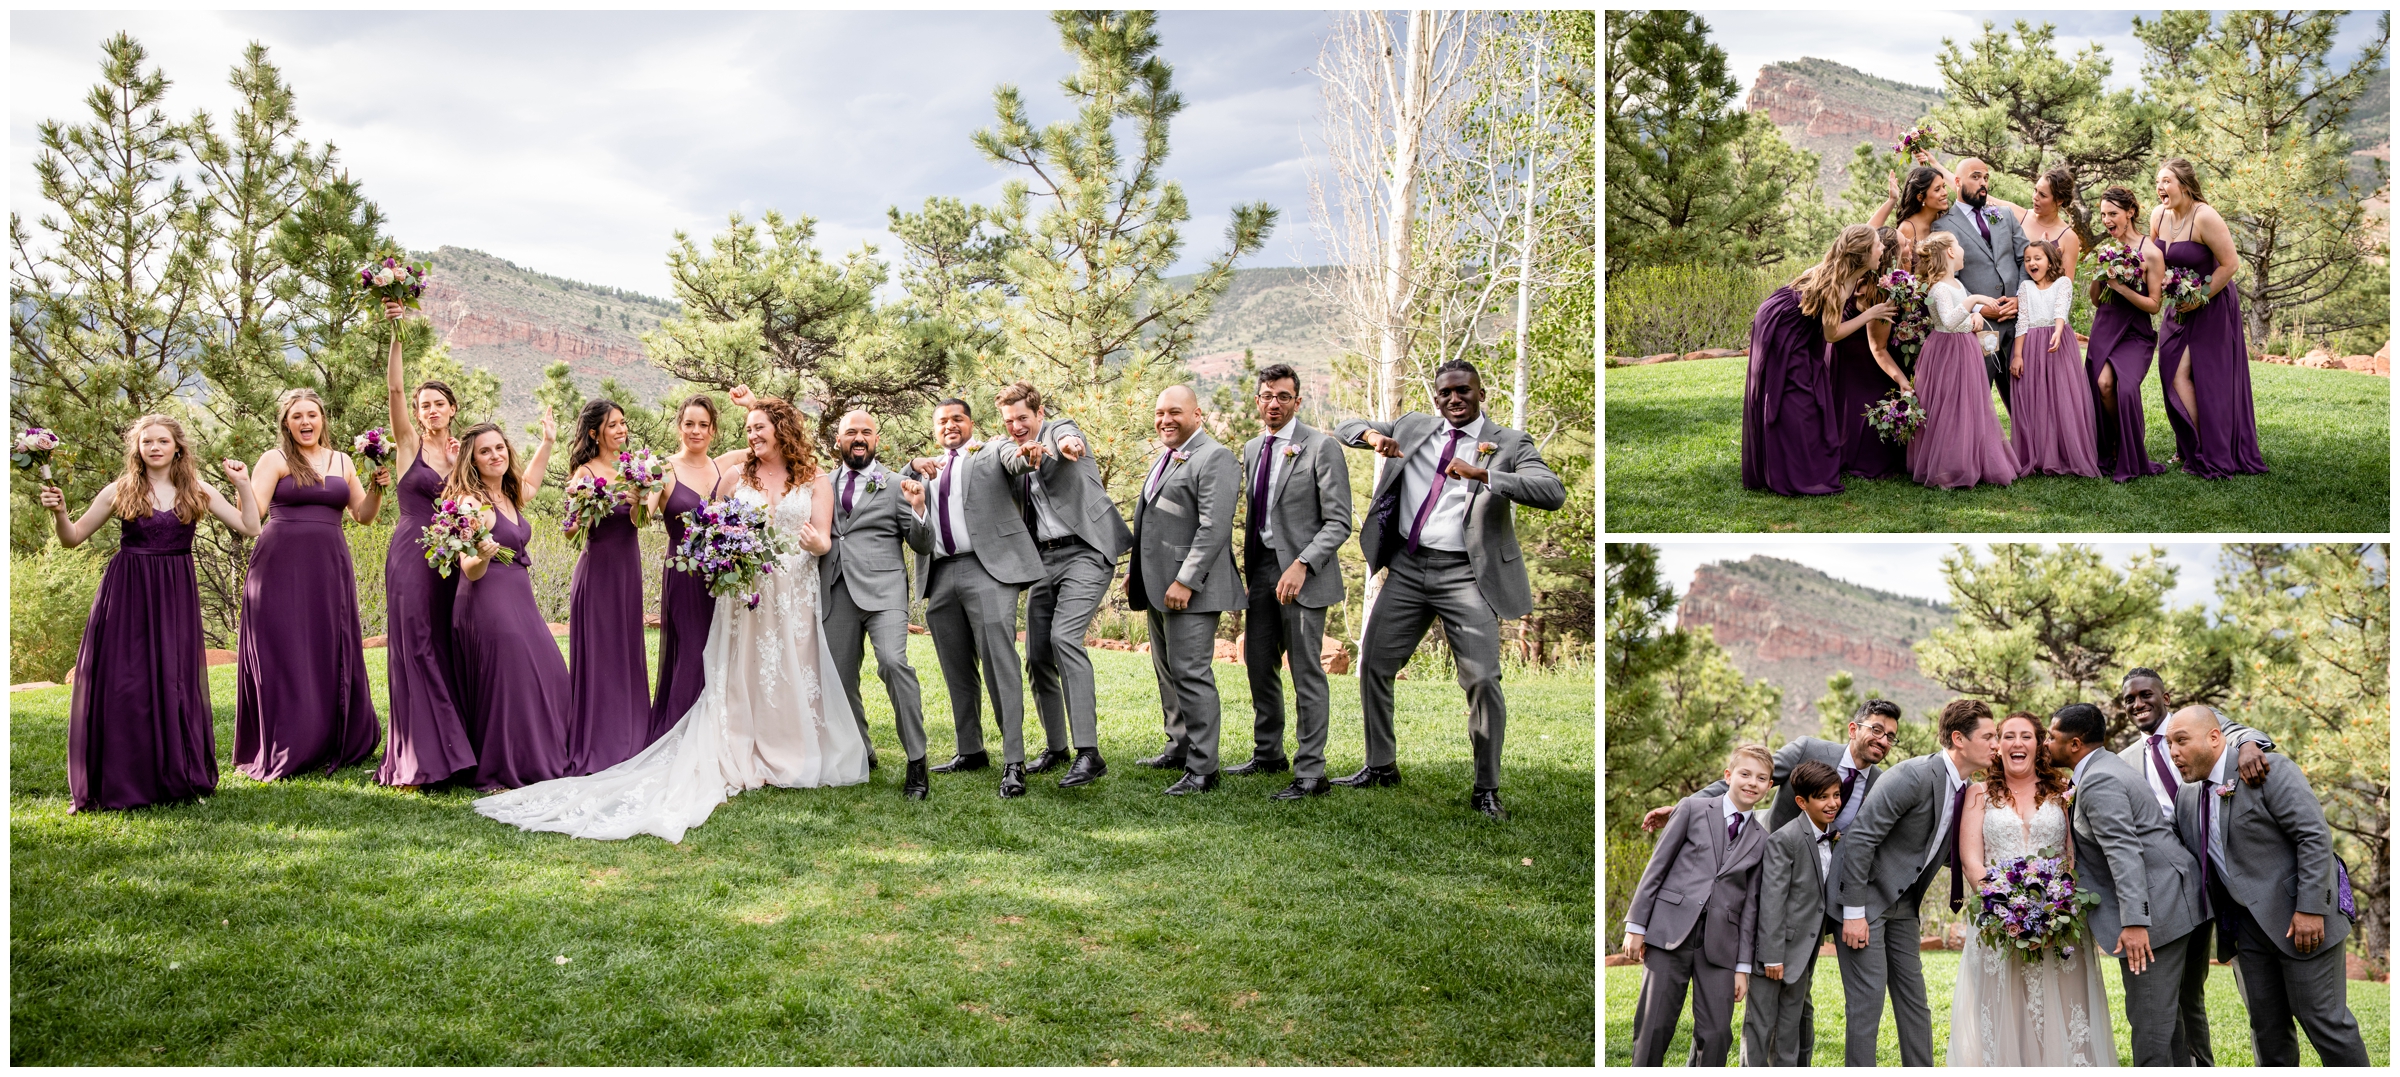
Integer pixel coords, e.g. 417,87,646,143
2045,703,2198,1065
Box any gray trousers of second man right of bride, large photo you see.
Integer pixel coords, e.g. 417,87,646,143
924,554,1025,763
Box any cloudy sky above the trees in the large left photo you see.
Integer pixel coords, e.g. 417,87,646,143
10,12,1327,295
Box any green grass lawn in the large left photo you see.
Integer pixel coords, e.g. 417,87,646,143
10,636,1596,1065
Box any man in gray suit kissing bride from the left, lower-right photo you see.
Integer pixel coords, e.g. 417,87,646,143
1834,700,1999,1065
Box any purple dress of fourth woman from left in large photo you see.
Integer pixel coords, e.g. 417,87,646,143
451,511,566,789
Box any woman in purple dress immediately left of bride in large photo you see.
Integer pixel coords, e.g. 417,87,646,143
643,393,725,744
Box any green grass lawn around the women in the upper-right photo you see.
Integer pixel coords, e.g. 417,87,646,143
1606,357,2390,533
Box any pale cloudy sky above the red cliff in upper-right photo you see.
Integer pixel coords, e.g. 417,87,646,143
1699,5,2376,94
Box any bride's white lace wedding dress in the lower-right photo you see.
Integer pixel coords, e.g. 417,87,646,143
1949,801,2117,1065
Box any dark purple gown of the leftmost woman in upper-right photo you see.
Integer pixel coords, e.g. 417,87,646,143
1742,285,1841,494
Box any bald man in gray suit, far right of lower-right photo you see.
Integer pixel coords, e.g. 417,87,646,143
2167,708,2369,1067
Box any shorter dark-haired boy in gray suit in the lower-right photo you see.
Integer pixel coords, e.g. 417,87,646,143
1742,760,1841,1065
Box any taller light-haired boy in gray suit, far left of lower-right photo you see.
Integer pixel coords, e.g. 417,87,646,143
1625,744,1776,1065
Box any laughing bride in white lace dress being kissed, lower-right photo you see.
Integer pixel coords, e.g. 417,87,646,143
1949,712,2117,1065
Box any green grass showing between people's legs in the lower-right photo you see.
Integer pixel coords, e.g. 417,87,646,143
1606,950,2393,1065
